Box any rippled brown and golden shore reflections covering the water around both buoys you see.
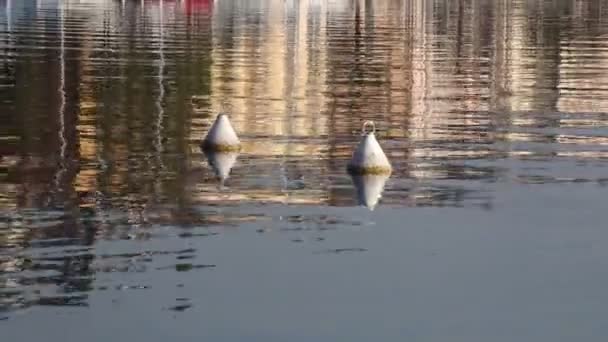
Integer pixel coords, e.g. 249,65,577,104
0,0,608,332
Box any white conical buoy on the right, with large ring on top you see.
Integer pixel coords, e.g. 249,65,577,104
348,121,392,175
